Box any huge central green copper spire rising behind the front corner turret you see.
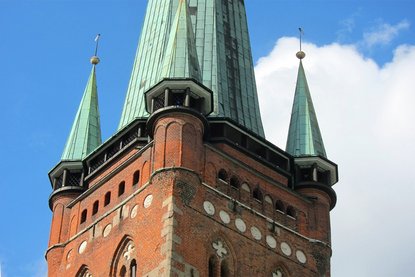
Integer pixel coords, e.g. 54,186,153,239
119,0,264,136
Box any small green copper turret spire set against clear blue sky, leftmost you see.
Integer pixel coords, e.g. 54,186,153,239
61,60,101,161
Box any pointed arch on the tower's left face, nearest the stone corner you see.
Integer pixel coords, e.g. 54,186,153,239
110,236,137,277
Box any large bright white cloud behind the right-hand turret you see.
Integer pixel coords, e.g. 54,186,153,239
255,37,415,277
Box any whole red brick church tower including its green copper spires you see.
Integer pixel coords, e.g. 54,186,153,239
46,0,337,277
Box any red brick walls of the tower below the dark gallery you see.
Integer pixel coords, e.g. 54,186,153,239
46,112,331,277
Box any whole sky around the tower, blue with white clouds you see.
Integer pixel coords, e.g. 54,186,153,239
0,0,415,277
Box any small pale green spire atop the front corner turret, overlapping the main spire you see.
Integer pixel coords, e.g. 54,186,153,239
160,0,202,82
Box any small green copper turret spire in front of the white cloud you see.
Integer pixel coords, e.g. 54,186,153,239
286,51,326,157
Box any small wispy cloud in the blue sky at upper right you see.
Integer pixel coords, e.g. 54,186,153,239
363,20,410,48
